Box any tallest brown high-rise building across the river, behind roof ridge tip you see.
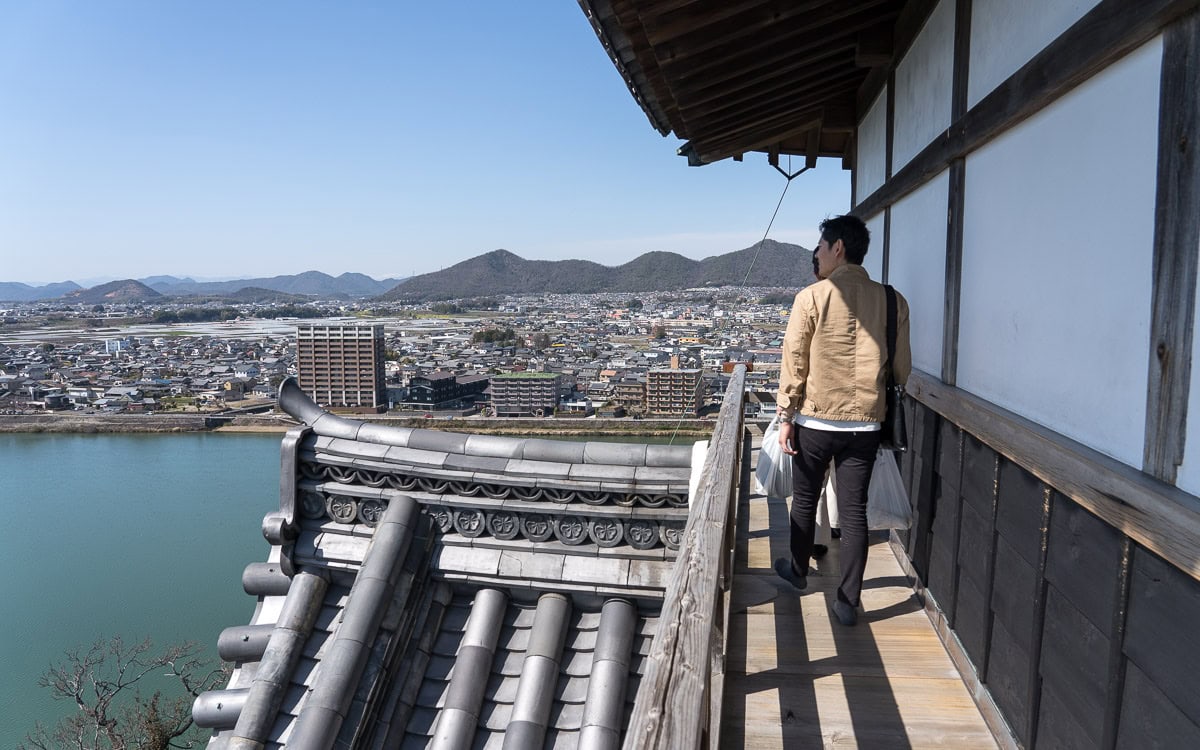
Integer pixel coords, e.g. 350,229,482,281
296,323,388,412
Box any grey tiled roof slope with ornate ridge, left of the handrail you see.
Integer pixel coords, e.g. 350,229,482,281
193,382,694,750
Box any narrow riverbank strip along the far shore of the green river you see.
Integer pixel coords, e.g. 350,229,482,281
0,412,713,438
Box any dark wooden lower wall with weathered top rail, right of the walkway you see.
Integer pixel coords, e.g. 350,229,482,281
893,371,1200,748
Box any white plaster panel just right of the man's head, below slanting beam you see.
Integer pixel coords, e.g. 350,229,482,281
888,172,950,377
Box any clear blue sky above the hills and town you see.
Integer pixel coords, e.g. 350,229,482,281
0,0,850,283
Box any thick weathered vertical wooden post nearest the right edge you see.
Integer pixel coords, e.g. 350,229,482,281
1142,13,1200,484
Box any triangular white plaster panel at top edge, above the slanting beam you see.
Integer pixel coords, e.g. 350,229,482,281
967,0,1099,107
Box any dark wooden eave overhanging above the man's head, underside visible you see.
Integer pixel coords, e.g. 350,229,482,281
580,0,907,166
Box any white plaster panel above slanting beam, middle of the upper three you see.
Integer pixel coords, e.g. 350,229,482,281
892,0,954,174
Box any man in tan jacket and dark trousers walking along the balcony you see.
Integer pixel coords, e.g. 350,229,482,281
775,216,912,625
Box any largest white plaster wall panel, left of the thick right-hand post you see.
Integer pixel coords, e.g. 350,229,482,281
958,40,1162,467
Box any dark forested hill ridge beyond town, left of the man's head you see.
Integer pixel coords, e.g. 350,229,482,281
379,240,812,301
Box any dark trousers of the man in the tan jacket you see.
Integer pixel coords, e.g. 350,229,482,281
791,426,880,606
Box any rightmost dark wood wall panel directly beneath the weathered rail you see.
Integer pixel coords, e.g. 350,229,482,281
1124,548,1200,724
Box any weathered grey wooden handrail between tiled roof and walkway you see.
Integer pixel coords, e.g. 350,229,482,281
624,365,745,750
